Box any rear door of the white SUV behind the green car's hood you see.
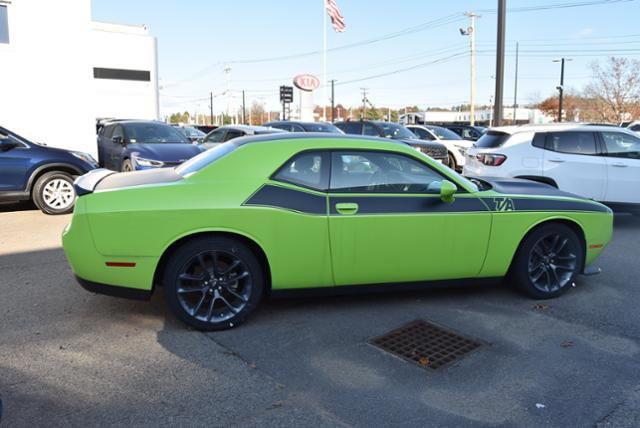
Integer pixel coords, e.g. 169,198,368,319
542,131,607,201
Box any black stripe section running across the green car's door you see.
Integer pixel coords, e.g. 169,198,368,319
329,196,488,215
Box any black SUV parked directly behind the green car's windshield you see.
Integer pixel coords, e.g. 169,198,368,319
335,120,449,164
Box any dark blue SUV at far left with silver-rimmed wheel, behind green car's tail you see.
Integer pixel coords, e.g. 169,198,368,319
0,127,97,214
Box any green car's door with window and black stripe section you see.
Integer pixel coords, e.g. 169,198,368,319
329,150,491,285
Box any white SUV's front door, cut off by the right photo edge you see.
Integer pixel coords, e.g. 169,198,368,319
600,132,640,204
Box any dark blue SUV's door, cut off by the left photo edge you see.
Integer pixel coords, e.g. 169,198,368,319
0,132,31,192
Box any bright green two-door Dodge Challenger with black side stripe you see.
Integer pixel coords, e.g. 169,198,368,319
63,134,613,330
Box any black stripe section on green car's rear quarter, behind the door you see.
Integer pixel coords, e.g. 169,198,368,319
242,184,327,215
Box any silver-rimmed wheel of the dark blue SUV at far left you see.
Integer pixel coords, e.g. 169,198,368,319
31,171,76,215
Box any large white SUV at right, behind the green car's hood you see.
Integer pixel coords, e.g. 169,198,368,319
463,123,640,209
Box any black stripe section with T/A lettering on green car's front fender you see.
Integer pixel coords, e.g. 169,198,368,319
483,197,608,213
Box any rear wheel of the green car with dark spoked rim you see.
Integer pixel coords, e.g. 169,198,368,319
163,236,265,331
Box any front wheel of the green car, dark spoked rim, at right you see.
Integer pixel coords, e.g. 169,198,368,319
509,223,584,299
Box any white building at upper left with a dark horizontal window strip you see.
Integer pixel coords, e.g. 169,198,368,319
0,0,158,155
